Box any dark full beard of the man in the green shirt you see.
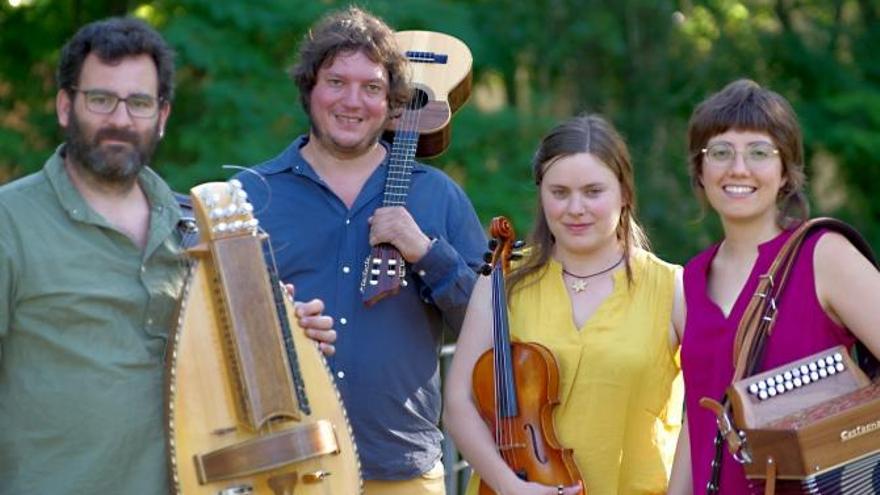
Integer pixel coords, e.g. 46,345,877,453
65,112,159,185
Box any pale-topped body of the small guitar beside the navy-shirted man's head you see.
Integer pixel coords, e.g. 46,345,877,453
386,31,473,158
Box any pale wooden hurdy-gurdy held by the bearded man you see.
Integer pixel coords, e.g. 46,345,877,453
166,180,362,495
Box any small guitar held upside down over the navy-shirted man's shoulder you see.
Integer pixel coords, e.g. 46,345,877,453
360,31,473,306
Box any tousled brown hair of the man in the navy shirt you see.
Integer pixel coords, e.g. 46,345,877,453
290,7,412,115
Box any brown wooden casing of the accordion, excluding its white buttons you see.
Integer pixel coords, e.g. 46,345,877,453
728,346,880,480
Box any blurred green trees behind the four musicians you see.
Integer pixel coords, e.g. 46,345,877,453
0,0,880,263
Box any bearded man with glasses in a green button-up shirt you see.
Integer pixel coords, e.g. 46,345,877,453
0,18,335,495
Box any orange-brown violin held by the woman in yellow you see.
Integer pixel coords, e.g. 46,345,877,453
472,217,586,495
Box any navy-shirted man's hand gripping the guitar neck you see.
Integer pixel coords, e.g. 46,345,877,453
369,206,431,263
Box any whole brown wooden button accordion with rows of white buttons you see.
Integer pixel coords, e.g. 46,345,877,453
728,346,880,494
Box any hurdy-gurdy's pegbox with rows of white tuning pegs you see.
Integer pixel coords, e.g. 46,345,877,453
190,179,259,241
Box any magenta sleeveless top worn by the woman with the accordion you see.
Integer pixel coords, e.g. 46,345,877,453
681,230,855,495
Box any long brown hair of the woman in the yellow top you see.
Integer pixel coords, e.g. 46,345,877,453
507,114,650,295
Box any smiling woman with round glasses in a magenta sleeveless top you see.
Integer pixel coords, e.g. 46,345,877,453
670,80,880,494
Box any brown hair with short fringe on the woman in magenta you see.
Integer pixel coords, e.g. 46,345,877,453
688,79,810,229
